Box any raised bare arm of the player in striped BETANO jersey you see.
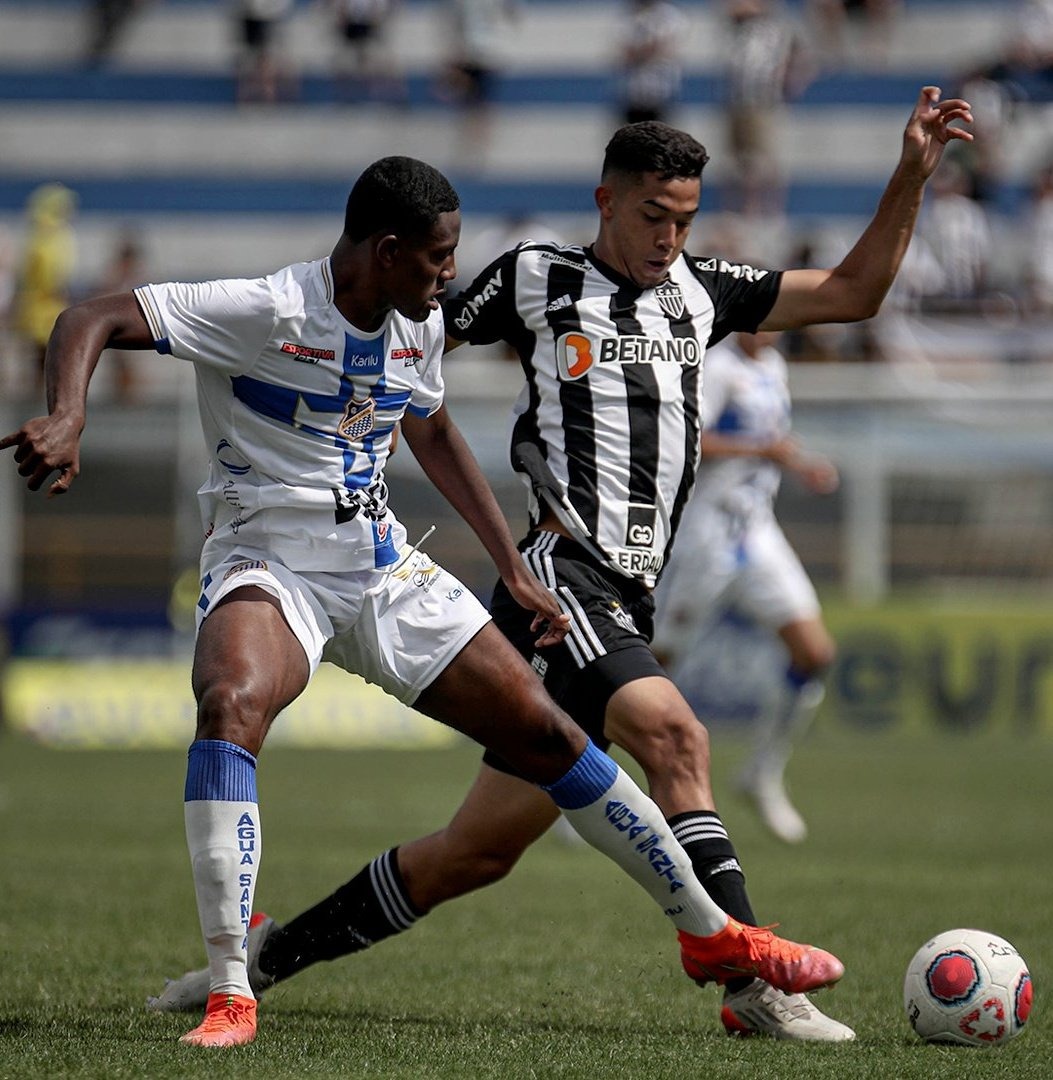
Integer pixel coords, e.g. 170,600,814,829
760,86,973,330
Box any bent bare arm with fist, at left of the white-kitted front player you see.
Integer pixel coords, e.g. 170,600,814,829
0,293,153,496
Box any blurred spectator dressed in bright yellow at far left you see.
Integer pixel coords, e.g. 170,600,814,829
14,184,77,394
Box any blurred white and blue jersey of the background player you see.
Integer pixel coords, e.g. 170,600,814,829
685,339,791,526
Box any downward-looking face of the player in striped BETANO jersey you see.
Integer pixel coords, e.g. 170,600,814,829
595,173,702,288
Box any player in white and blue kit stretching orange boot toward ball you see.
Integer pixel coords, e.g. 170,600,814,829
0,158,843,1047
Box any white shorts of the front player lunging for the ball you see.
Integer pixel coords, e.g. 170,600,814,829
198,542,490,705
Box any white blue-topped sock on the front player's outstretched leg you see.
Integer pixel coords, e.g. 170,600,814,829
544,742,728,937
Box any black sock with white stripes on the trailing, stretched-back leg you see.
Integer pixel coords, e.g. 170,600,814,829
257,848,421,982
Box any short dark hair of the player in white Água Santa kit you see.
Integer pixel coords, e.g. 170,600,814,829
343,157,461,243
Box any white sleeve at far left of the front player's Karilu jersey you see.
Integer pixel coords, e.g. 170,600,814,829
135,278,278,375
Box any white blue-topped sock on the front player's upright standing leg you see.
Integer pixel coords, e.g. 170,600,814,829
184,739,261,998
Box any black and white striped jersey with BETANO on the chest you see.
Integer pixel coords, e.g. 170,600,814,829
444,241,781,585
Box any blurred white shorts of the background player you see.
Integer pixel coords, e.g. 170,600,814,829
654,509,821,657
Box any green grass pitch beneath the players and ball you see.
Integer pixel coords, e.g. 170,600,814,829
0,721,1053,1080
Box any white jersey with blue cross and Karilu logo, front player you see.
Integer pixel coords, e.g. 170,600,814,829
135,258,444,570
